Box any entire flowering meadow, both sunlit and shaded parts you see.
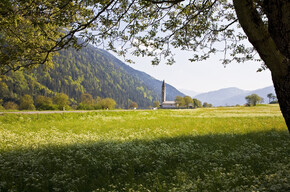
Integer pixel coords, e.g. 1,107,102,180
0,105,290,192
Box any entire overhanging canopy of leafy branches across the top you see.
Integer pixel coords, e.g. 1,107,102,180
0,0,253,74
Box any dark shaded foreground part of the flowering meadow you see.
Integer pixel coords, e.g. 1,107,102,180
0,131,290,192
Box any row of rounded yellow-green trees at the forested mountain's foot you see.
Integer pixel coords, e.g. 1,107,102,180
0,93,117,110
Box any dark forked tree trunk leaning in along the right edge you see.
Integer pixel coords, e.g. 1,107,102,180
233,0,290,132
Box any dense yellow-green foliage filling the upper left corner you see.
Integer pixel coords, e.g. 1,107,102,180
0,0,93,74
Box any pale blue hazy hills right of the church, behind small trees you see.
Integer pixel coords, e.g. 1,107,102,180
195,86,275,106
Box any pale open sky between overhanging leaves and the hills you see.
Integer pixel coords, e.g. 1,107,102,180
109,48,273,93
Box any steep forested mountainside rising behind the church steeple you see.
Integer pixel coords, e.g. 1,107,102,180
0,46,183,108
